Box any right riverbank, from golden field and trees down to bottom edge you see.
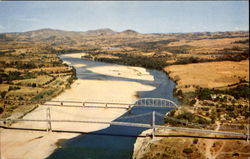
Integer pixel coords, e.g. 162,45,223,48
133,60,250,159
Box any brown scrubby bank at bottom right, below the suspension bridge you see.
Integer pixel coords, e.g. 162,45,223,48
133,127,250,159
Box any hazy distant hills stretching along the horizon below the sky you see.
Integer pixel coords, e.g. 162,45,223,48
0,28,249,46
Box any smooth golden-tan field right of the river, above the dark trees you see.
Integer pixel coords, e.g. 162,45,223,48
164,60,249,92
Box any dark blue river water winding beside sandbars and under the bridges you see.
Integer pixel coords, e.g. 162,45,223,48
48,56,179,159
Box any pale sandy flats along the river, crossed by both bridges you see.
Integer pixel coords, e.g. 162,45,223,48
0,54,160,159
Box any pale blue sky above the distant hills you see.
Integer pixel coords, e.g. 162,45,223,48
0,1,249,33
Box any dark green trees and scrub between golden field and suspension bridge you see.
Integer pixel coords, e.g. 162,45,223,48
168,83,250,130
